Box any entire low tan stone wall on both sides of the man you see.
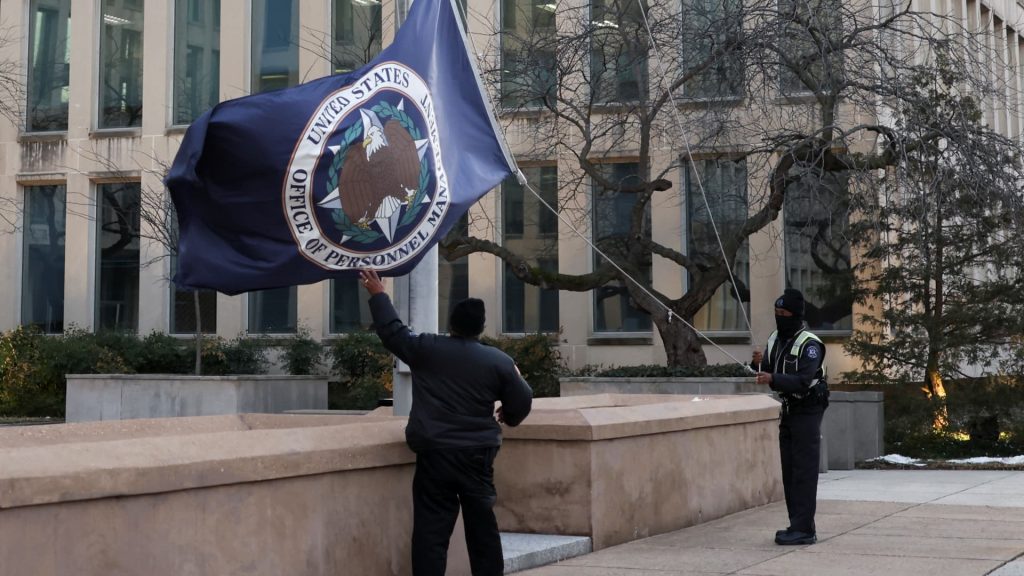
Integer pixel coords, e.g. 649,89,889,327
0,395,780,576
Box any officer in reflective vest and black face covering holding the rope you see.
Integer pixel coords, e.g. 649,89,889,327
752,288,828,545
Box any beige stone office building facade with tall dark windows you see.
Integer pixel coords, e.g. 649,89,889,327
0,0,1024,373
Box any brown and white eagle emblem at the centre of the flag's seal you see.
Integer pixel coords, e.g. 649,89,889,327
317,100,429,242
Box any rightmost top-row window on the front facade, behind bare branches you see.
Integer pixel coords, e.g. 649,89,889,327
778,0,843,94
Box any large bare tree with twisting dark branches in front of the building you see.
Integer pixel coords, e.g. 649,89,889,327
441,0,1022,365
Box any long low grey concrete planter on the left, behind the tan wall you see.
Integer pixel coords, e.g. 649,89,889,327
66,374,327,422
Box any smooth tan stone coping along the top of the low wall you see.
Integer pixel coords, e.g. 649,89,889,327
0,395,779,509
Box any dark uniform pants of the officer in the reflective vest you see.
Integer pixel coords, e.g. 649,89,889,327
778,407,824,534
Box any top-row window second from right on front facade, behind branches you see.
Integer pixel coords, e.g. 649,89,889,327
681,0,743,98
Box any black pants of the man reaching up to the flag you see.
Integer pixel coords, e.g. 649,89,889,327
413,446,505,576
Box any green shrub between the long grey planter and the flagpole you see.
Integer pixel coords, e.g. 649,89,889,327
328,332,392,410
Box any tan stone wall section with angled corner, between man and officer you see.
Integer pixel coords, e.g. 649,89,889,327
495,395,782,550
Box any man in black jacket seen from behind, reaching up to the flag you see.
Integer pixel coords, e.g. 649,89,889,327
360,271,534,576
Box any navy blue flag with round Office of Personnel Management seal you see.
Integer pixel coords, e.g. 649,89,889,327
173,0,514,294
